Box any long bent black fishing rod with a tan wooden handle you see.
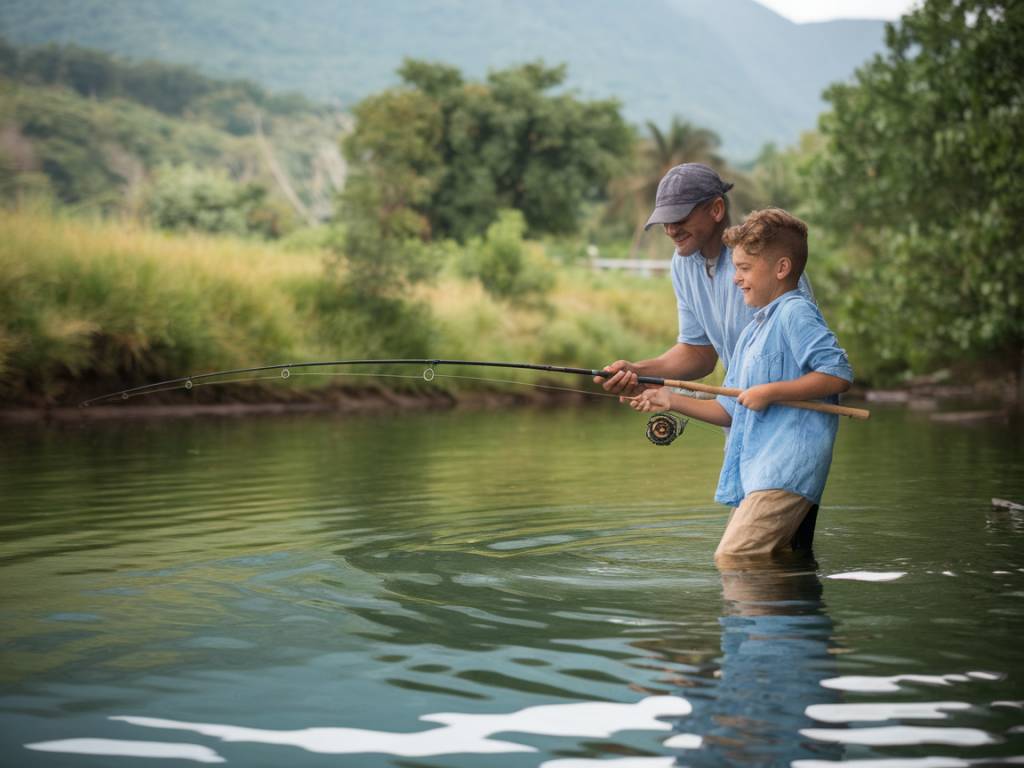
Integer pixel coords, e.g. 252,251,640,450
80,357,870,420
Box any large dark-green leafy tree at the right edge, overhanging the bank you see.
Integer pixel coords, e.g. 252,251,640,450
814,0,1024,382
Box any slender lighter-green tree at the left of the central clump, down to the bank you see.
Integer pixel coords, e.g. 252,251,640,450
317,90,440,357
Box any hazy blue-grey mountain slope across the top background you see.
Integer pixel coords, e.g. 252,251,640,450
0,0,884,161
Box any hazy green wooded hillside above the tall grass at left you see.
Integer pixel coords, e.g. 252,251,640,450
0,40,344,225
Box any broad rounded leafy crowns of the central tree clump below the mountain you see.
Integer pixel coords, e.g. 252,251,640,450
346,60,631,241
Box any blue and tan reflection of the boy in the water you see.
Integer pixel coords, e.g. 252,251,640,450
679,557,842,766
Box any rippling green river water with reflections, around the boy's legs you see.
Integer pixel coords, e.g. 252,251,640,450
0,404,1024,768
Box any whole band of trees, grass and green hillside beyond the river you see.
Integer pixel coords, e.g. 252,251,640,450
0,0,1024,402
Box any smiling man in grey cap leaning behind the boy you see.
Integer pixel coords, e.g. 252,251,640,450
594,163,812,395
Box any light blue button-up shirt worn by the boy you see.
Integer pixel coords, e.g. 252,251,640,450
715,291,853,507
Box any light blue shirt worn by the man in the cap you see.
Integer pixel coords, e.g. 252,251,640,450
672,245,814,371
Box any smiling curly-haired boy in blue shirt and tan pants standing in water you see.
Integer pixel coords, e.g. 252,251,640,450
631,208,853,560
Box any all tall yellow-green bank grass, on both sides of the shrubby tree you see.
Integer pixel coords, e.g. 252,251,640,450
0,208,676,403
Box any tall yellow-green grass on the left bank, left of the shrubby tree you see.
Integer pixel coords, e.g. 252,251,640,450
0,204,319,399
